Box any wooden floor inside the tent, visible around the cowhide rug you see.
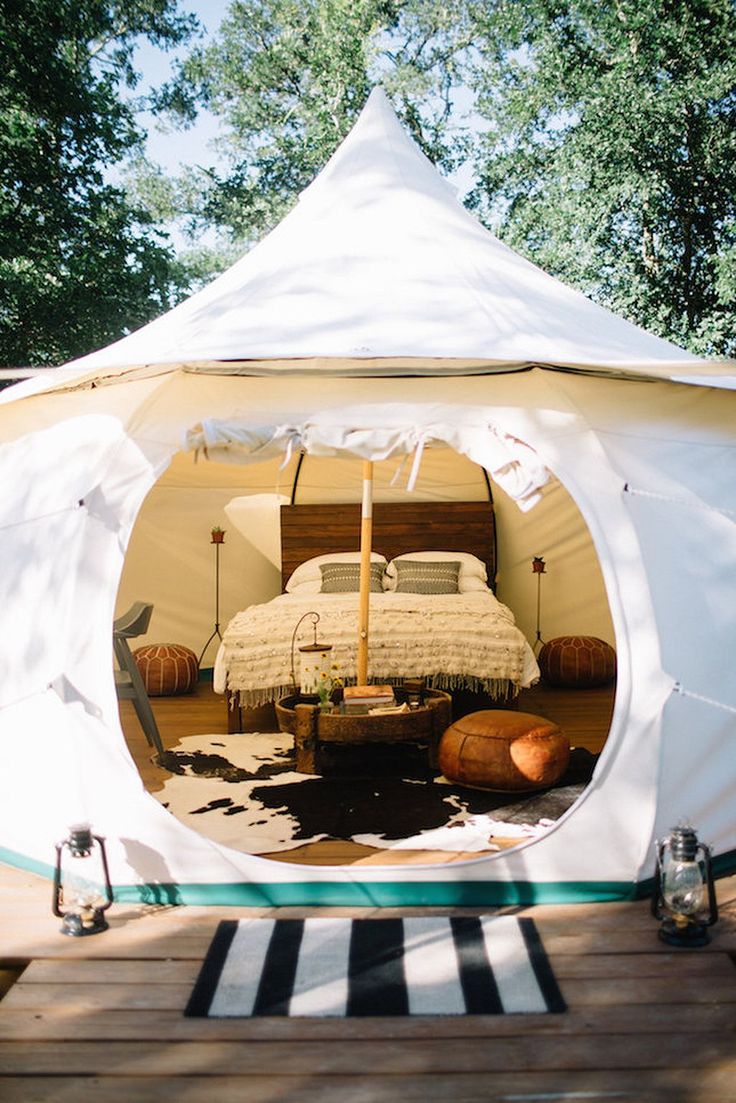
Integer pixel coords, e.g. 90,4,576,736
120,682,614,865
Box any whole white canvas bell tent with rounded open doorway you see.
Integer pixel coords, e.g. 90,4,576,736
0,92,736,904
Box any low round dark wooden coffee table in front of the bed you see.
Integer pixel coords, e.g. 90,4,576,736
276,689,452,773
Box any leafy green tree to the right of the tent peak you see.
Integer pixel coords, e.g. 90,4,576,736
470,0,736,355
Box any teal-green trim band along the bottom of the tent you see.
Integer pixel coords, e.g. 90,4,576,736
0,848,736,908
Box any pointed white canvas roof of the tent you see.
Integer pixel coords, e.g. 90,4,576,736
50,85,733,381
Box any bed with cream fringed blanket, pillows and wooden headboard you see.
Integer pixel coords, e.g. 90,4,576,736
214,502,538,731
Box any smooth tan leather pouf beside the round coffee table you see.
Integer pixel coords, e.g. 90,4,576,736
439,708,569,792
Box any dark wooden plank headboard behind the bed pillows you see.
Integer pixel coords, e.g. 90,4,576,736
281,502,495,588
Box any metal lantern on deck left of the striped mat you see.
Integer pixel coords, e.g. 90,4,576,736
52,824,113,938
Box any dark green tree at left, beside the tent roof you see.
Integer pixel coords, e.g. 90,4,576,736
0,0,194,366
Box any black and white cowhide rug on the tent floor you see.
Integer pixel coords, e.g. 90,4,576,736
156,732,596,854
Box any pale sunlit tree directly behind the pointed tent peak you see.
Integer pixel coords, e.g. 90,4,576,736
156,0,469,244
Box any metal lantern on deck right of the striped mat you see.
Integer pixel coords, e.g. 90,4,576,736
652,825,718,946
